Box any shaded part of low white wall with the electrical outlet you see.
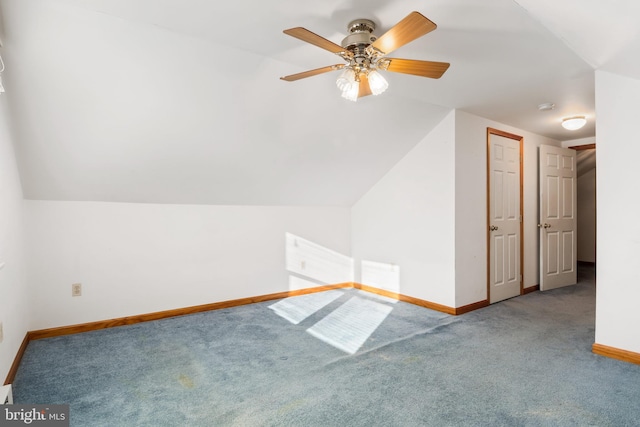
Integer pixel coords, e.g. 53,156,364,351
25,201,350,329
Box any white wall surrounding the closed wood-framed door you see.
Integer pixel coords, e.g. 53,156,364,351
455,111,560,307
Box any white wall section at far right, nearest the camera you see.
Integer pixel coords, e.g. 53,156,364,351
596,71,640,353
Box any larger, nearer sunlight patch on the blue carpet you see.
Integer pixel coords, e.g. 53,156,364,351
307,297,393,354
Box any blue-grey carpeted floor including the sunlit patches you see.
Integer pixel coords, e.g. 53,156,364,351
14,269,640,427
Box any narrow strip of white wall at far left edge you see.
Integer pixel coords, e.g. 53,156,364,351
0,98,31,384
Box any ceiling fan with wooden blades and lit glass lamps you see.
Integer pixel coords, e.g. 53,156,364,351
280,12,449,101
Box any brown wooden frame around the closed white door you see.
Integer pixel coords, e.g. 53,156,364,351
485,127,524,301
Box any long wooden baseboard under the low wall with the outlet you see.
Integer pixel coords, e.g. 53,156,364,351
28,282,352,340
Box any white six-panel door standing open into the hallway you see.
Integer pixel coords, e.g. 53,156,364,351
538,145,577,291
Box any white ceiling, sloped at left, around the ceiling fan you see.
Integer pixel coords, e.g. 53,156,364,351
0,0,635,206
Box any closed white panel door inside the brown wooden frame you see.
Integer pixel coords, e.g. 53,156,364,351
488,129,522,304
